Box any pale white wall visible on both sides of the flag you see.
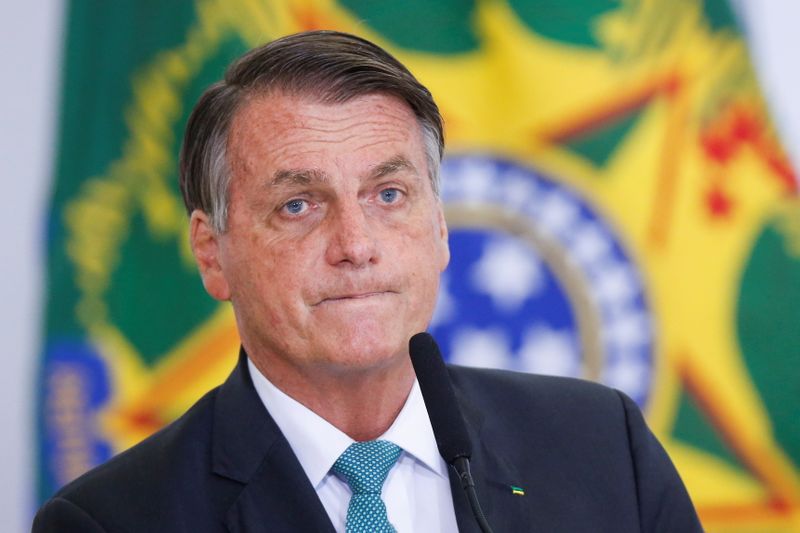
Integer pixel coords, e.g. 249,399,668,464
0,0,800,533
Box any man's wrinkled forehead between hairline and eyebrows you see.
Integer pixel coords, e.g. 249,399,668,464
228,93,424,172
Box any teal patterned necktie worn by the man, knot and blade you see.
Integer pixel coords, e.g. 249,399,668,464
331,440,402,533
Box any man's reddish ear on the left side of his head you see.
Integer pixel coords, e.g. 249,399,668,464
189,209,231,300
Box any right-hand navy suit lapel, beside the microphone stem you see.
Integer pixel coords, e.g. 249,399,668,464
450,368,530,533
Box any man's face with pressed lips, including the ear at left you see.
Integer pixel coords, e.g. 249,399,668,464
192,94,449,374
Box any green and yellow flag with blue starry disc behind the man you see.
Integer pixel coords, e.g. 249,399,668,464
37,0,800,532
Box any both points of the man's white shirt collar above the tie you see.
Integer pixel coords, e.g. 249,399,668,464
247,358,447,488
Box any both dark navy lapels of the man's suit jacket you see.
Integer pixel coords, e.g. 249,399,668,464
212,352,530,533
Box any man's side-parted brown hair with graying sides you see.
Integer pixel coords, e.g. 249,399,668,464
180,31,444,233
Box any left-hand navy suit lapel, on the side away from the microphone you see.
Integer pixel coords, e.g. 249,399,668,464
212,351,334,533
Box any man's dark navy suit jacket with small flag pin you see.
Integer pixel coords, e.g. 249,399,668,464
33,357,701,533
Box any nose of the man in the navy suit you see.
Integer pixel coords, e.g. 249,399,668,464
325,202,378,268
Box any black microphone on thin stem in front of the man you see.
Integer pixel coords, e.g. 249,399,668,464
408,333,492,533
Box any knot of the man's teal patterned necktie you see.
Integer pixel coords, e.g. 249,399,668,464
333,440,402,494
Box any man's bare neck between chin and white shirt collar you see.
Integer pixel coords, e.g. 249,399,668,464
251,348,414,441
